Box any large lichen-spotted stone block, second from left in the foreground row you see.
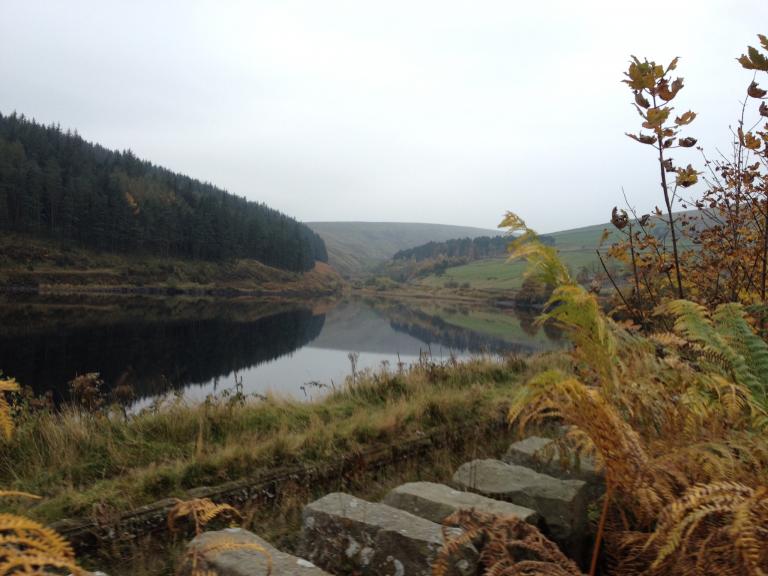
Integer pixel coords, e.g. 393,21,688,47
300,492,477,576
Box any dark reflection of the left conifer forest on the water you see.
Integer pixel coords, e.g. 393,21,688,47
0,309,325,401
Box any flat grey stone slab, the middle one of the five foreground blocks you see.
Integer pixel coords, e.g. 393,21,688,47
382,482,540,524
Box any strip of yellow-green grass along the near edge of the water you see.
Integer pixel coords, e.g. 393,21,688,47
0,359,564,522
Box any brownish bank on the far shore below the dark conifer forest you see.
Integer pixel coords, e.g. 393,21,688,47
0,233,343,296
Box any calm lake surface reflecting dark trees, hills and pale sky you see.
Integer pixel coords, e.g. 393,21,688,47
0,296,560,408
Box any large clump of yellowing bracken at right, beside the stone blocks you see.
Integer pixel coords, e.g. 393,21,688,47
505,216,768,576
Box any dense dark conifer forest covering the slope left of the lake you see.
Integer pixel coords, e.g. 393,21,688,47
0,114,328,271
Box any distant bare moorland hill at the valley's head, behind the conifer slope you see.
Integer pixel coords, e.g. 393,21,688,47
307,222,499,277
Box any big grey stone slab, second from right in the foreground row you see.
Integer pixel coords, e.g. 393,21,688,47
453,460,588,548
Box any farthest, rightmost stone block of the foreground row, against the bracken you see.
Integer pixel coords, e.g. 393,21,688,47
502,436,603,485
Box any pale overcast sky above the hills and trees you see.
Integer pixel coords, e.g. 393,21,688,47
0,0,768,232
